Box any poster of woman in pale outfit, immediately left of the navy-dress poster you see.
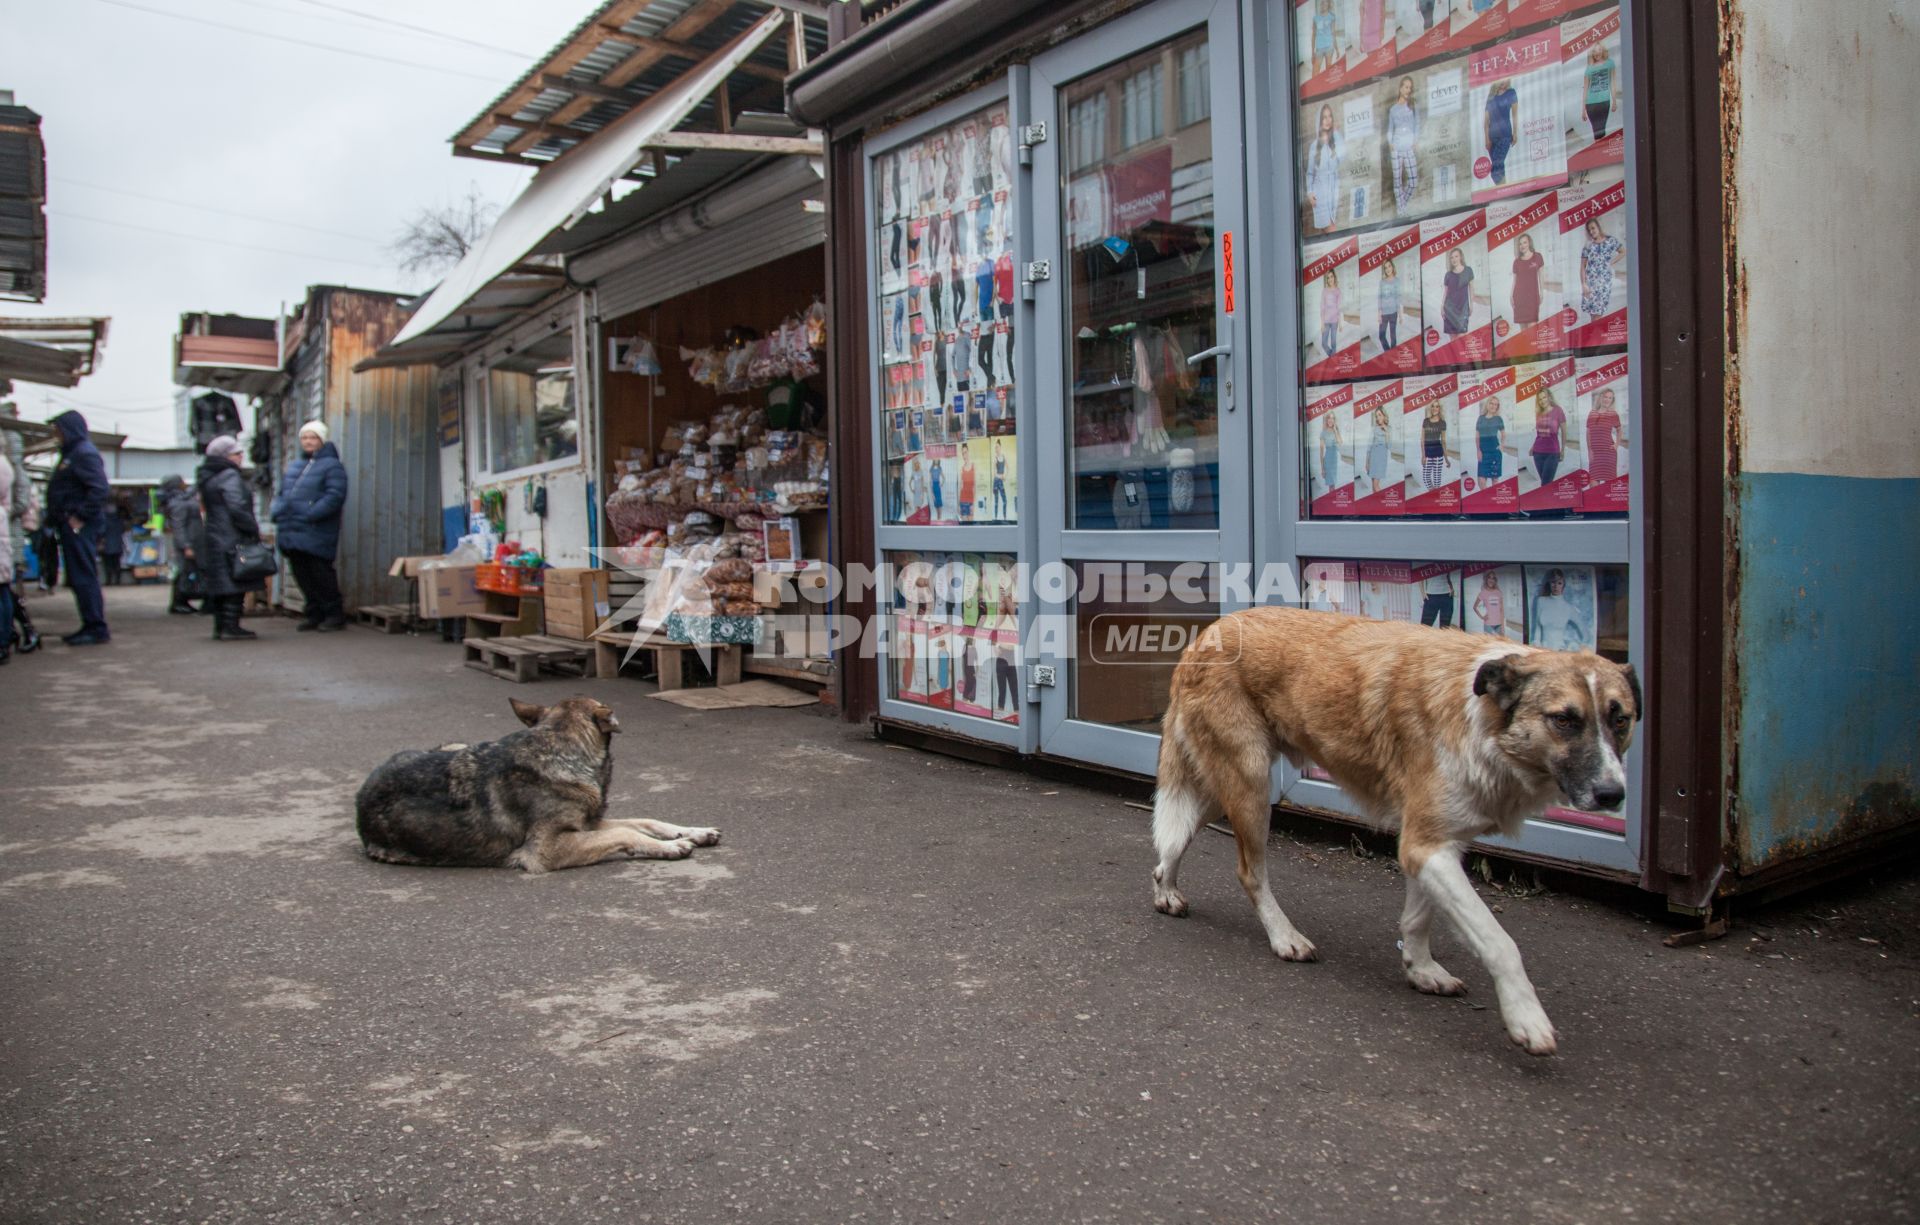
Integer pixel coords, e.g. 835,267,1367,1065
1373,60,1473,219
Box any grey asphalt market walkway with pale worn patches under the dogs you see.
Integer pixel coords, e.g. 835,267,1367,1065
0,589,1920,1223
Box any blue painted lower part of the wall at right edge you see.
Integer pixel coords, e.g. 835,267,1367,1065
1734,472,1920,870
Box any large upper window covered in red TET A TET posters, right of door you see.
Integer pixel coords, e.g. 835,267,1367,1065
1292,0,1636,520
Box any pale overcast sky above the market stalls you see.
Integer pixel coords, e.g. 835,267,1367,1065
0,0,597,445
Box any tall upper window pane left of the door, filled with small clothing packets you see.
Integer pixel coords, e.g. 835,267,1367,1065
874,104,1020,526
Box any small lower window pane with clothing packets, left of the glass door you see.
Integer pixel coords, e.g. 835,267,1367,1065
887,551,1025,724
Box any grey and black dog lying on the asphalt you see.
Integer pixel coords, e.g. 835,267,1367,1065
353,697,720,872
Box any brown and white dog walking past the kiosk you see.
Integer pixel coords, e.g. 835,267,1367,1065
1154,609,1640,1054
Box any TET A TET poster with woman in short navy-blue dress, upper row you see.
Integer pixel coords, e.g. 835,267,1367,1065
1467,27,1567,204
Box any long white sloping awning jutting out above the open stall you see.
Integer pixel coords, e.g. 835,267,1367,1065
388,8,787,349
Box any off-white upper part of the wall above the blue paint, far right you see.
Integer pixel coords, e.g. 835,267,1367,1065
1735,0,1920,476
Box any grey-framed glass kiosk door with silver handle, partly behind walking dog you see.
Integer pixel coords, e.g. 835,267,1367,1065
1023,0,1252,774
